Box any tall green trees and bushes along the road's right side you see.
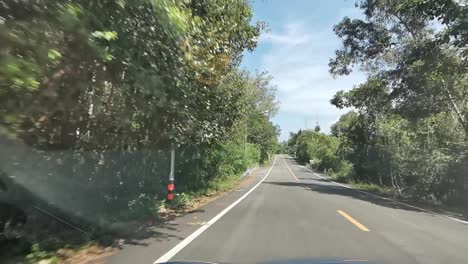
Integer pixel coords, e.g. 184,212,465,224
330,0,468,200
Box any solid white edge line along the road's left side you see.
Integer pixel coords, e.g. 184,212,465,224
153,156,278,264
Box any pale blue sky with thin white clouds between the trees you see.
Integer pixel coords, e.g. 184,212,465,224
242,0,364,140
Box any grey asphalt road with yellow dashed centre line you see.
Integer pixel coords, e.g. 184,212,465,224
109,156,468,264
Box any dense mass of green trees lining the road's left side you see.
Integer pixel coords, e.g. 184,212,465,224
0,0,278,231
